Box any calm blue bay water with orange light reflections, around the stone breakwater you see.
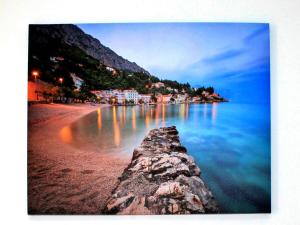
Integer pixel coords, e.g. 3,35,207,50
60,103,271,213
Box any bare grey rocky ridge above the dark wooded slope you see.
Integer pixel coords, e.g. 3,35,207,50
29,24,150,74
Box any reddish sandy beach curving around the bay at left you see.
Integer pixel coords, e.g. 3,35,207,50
28,104,130,214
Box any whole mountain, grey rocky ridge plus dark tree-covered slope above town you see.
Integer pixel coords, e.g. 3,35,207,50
28,25,211,96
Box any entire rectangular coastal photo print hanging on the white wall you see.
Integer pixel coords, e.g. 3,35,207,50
28,23,271,215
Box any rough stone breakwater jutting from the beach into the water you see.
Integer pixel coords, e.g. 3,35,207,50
103,126,219,215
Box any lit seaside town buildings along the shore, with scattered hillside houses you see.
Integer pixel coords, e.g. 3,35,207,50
28,64,227,105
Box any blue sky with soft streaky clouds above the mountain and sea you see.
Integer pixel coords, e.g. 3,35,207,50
77,23,270,103
